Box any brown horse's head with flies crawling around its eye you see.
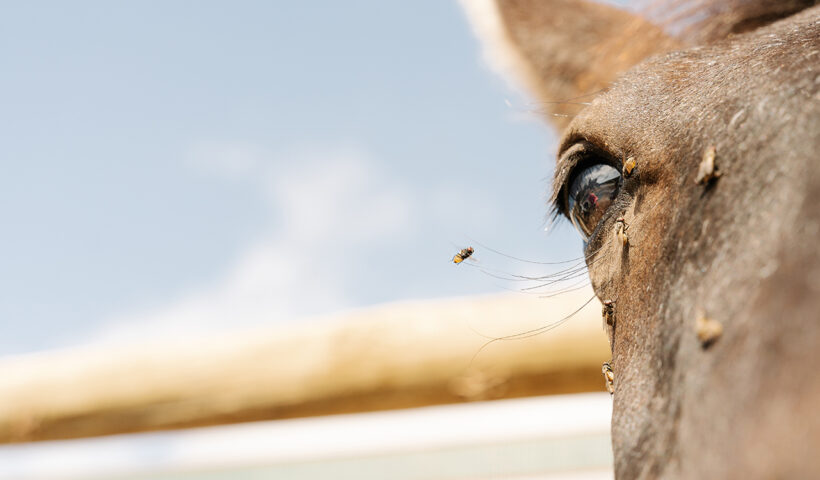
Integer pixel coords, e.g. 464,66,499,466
462,0,820,479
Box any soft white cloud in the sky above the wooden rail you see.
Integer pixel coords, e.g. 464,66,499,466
95,144,414,341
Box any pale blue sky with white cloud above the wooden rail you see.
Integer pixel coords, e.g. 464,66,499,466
0,0,581,355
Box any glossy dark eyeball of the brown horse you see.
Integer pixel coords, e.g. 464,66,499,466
568,164,621,240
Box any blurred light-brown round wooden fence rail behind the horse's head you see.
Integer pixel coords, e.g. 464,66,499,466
0,290,609,443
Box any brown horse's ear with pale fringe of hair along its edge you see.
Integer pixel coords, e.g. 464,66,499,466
461,0,680,129
